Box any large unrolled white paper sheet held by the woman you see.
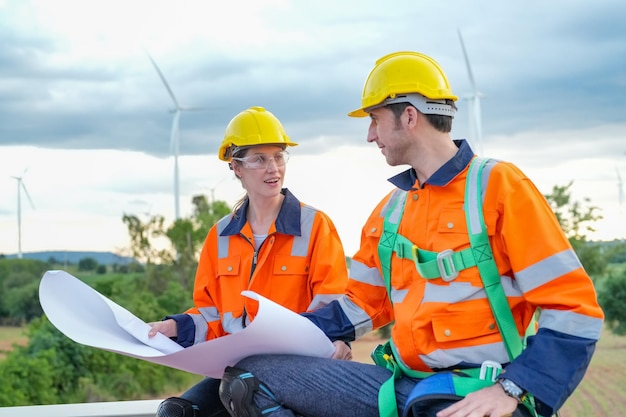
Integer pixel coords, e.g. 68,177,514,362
39,271,335,378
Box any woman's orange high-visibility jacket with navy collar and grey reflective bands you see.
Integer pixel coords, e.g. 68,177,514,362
170,189,348,346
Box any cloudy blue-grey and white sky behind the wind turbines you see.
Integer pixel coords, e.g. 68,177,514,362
0,0,626,255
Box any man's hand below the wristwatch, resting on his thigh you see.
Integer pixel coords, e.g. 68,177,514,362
437,384,518,417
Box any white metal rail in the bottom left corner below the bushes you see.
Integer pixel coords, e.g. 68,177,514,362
0,400,163,417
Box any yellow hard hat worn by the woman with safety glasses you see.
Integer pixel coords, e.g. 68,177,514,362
217,106,297,162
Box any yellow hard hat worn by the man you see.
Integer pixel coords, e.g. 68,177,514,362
348,52,458,117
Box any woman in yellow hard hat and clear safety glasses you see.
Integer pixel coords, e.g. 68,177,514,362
152,107,351,417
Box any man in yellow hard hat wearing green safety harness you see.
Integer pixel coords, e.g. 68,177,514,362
220,52,604,417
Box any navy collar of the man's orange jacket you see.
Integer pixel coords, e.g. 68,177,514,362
388,139,474,191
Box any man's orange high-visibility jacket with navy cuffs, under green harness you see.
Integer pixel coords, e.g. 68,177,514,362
307,141,603,408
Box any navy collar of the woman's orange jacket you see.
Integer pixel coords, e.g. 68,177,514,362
220,188,302,236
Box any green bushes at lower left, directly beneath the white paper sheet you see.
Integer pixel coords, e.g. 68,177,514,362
0,317,199,406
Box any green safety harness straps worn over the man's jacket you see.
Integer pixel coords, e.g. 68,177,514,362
371,157,536,417
